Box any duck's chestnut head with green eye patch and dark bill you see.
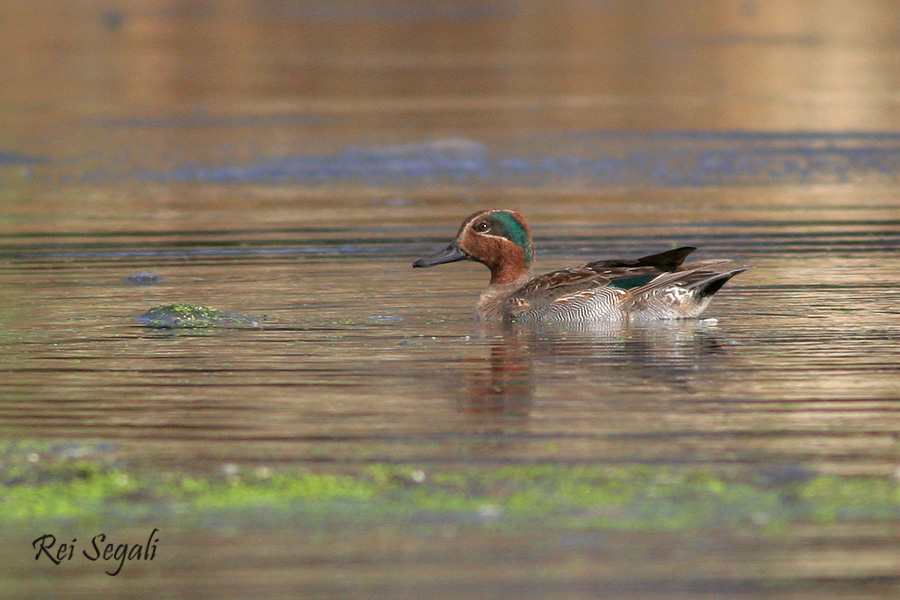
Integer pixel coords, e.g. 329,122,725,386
413,209,534,285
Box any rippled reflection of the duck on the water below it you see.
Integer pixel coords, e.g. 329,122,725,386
459,319,727,424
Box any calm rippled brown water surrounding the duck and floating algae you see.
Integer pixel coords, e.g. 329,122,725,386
0,0,900,598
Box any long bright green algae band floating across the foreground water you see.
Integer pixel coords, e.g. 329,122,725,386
0,442,900,535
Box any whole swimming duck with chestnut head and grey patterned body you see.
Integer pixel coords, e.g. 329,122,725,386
412,209,749,323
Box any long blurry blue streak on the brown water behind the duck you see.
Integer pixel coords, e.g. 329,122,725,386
121,131,900,186
